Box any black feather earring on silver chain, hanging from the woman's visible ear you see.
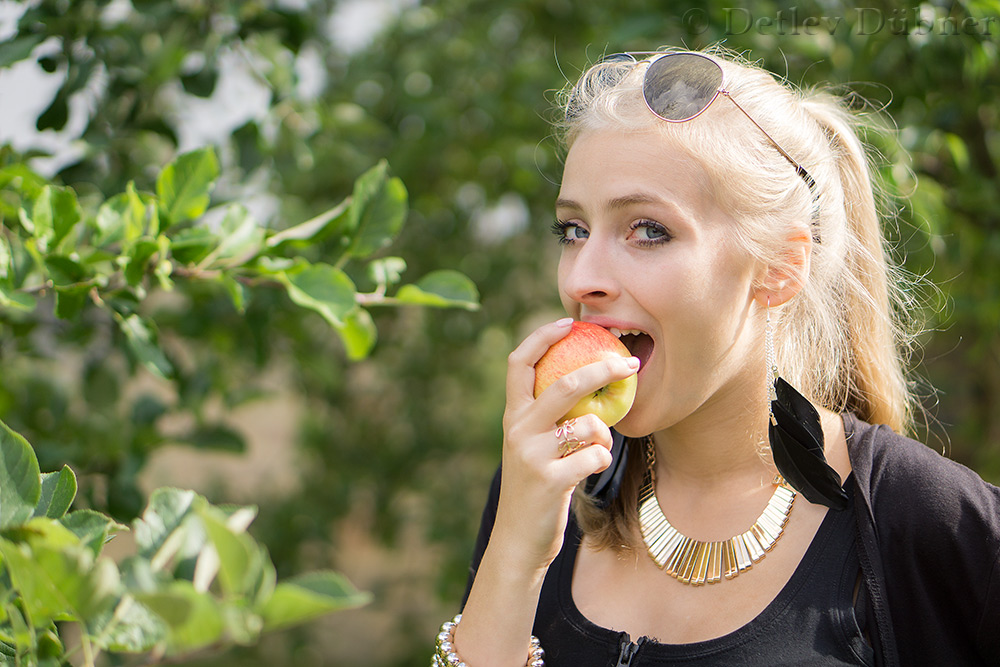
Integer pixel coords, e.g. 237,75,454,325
764,303,847,510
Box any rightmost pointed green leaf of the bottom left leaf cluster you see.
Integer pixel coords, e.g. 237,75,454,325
260,572,372,631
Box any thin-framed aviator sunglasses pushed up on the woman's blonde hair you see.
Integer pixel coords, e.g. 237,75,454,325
566,51,819,235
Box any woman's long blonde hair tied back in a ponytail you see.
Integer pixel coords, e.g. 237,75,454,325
559,49,915,548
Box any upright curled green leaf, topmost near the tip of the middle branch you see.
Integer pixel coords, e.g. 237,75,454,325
347,160,408,257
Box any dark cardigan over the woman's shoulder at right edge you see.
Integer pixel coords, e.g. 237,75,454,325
844,416,1000,664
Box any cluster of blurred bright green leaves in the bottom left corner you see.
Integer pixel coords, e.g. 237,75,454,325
0,422,370,667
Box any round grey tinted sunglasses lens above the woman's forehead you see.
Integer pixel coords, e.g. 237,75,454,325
642,53,722,122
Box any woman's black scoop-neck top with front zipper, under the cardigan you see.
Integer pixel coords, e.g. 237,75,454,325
466,470,874,667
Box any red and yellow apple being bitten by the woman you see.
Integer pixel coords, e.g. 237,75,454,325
535,322,638,426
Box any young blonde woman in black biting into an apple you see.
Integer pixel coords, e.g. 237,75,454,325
434,52,1000,667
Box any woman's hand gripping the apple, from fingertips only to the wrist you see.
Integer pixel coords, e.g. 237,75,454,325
490,318,639,569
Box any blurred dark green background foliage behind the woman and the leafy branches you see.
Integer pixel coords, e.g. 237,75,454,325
0,0,1000,665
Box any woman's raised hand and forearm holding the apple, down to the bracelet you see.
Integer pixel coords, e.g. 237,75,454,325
455,319,639,667
